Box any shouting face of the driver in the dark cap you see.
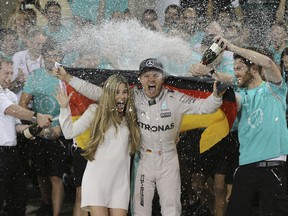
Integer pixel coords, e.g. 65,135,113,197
140,69,164,98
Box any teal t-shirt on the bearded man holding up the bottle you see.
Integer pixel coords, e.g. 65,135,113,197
238,82,288,165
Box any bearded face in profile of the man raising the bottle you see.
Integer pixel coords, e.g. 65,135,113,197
234,59,254,87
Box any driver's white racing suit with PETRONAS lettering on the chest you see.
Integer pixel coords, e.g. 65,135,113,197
69,77,222,216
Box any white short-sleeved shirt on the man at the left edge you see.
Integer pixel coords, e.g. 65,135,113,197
0,86,21,146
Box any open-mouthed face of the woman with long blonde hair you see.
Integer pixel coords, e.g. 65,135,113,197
115,83,128,115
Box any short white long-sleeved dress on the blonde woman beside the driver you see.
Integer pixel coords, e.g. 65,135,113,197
59,105,130,210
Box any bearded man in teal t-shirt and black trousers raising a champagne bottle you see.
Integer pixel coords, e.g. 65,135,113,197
194,36,288,216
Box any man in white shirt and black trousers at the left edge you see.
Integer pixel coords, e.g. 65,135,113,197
0,55,51,216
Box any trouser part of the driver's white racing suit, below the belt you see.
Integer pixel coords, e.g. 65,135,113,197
134,148,181,216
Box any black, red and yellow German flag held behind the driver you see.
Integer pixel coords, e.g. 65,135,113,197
65,68,237,153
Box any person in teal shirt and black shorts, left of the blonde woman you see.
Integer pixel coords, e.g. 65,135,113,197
19,40,68,215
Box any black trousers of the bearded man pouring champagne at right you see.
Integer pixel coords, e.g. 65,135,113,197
226,164,288,216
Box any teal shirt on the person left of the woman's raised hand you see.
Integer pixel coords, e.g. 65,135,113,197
23,68,60,127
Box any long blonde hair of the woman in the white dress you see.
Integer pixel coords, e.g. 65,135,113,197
83,74,140,161
